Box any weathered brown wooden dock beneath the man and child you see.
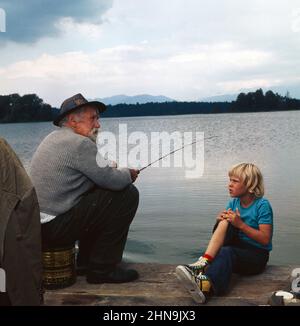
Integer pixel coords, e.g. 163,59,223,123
44,264,294,306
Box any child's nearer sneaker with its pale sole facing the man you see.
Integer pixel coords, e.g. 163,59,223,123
176,265,211,303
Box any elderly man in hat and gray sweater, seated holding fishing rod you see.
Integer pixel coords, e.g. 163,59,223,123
30,94,139,284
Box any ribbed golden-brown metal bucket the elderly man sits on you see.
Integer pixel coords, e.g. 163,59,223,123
43,246,76,290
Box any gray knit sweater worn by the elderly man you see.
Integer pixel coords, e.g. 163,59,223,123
30,127,132,222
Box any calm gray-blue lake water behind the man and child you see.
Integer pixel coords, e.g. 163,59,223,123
0,112,300,265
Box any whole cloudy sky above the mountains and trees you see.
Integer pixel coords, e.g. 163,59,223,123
0,0,300,106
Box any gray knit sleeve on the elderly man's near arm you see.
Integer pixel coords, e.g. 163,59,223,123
77,138,132,191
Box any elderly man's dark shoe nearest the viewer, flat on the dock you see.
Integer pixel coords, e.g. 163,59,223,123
86,267,139,284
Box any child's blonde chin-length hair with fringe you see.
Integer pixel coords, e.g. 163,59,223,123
228,163,265,197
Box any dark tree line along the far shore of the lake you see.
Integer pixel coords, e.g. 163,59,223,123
0,89,300,123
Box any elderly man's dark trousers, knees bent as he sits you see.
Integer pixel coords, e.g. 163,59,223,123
42,185,139,272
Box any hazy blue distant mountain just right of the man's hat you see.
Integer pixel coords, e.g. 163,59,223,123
94,94,175,105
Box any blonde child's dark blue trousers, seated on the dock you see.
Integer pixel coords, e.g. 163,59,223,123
205,224,269,295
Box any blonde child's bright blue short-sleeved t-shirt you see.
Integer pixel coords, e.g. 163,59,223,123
226,198,273,251
